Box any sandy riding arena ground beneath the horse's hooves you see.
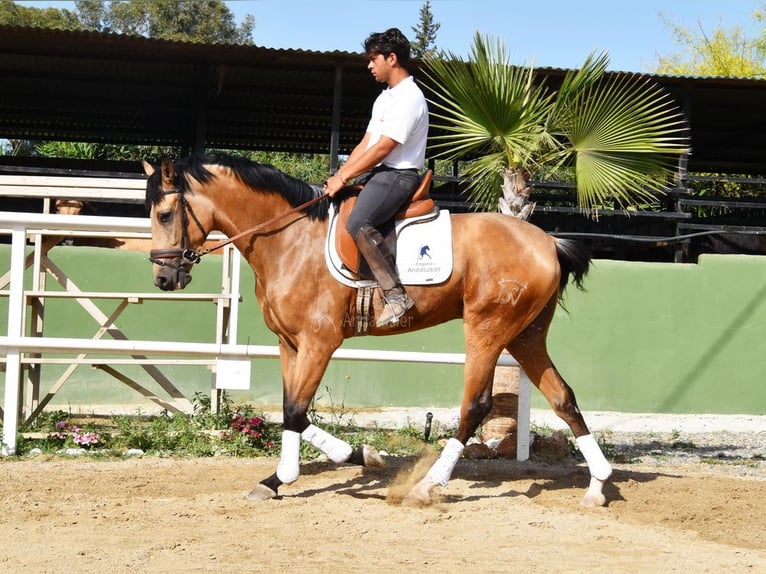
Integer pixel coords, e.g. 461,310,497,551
0,456,766,574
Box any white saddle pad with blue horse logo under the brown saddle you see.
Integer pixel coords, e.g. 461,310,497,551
325,206,452,288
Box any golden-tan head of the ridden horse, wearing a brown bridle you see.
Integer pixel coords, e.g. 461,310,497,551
142,159,211,291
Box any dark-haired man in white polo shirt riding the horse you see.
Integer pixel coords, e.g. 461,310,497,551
325,28,428,327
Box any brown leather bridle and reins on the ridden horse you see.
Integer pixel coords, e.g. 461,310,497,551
149,187,330,272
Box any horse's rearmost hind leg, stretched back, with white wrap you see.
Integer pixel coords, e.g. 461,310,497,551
507,300,612,506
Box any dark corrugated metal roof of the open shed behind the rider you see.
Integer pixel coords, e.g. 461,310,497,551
0,26,766,173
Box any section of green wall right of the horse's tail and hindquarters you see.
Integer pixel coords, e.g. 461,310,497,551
550,255,766,414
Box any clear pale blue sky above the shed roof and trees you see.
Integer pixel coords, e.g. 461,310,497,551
17,0,766,72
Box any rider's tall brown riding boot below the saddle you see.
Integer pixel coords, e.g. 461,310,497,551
356,225,415,327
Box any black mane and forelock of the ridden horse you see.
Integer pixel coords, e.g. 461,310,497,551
146,154,329,220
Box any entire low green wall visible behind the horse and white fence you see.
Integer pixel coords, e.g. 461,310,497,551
0,245,766,414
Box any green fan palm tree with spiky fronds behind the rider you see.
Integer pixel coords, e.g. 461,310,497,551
423,32,688,219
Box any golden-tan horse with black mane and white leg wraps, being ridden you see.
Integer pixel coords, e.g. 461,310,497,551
143,155,612,507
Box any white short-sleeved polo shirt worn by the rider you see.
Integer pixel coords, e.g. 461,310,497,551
367,76,428,171
